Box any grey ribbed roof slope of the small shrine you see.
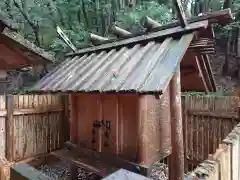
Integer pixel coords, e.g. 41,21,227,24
31,34,193,93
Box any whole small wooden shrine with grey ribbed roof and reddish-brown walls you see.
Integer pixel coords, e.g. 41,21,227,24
31,6,232,180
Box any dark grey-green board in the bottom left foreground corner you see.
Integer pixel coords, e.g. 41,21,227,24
11,164,53,180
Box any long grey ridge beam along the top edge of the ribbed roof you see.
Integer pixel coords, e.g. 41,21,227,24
66,21,208,56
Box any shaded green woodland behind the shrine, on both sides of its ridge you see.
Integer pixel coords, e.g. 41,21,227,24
0,0,240,91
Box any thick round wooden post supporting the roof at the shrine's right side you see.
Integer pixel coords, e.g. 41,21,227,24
169,67,184,180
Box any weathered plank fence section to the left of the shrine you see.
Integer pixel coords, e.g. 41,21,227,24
0,95,68,161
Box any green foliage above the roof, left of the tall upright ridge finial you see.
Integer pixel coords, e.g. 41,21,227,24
0,0,174,57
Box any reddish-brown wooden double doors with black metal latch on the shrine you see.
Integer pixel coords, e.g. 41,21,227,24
76,94,138,160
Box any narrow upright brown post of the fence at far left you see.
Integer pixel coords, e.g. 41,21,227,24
6,94,14,161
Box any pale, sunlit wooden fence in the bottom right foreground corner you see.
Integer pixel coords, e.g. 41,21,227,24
189,124,240,180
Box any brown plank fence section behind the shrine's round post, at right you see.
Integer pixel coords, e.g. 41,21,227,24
182,96,240,171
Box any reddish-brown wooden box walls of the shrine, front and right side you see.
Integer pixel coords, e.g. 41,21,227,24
71,90,171,165
